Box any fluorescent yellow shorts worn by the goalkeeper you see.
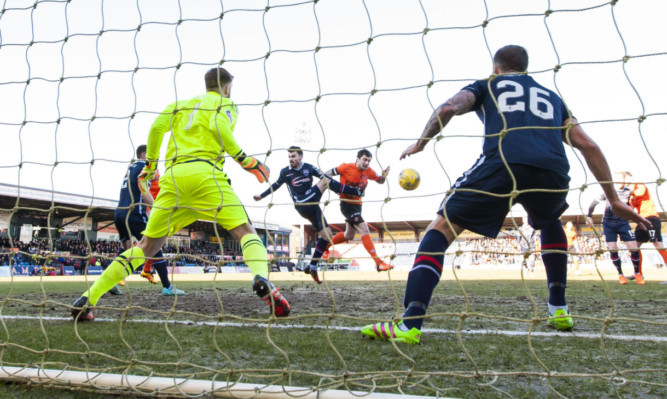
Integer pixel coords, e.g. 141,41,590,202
143,162,250,238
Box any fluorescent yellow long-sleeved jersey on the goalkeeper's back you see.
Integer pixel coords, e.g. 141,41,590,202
146,92,243,170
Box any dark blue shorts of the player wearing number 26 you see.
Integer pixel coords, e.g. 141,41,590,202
438,162,570,238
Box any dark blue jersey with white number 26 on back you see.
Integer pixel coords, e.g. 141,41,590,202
463,74,571,174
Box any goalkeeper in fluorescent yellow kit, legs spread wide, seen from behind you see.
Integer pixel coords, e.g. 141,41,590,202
72,68,290,320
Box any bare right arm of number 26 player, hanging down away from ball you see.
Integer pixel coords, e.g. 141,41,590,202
563,118,651,230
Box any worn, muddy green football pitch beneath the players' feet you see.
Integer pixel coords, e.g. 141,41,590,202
0,269,667,398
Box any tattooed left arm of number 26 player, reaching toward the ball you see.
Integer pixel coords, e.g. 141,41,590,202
400,90,476,159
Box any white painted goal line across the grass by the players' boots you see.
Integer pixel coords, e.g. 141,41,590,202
0,315,667,343
